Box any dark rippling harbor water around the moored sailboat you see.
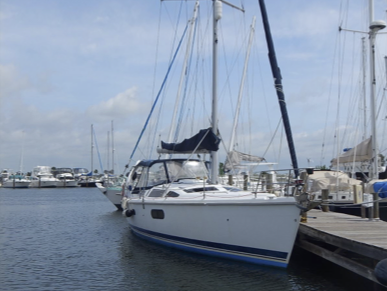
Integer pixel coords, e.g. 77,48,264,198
0,188,372,291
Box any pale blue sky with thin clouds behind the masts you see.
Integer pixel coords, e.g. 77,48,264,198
0,0,387,173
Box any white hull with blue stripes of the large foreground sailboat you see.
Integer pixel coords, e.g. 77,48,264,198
128,197,300,267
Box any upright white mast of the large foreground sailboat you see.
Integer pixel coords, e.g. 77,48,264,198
211,0,222,184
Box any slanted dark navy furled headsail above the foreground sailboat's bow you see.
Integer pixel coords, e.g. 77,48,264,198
259,0,299,178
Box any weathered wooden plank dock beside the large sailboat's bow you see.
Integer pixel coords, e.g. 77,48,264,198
296,209,387,286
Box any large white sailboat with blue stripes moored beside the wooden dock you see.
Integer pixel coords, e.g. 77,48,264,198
122,0,310,268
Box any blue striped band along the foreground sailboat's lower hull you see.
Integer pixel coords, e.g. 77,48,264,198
130,225,288,268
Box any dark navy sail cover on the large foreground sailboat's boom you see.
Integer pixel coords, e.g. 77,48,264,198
161,127,220,153
